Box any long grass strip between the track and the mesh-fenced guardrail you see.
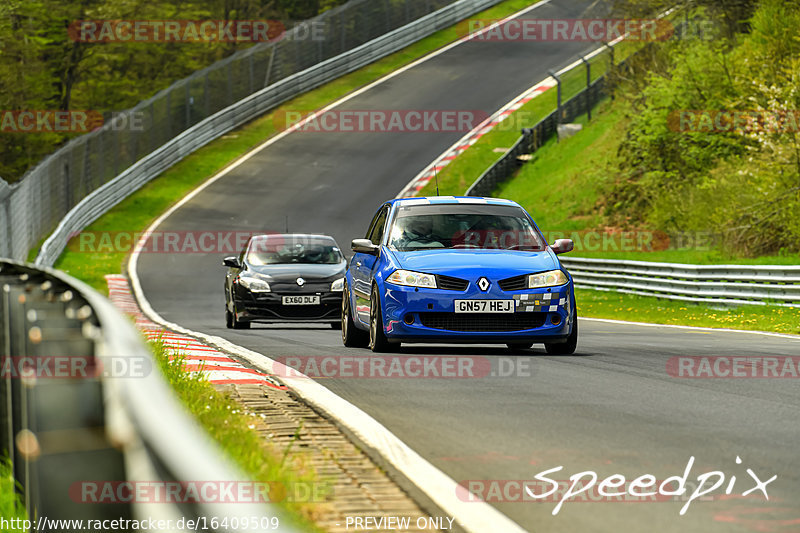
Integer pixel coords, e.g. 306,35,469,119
50,0,552,293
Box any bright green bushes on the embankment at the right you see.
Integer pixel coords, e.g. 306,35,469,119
605,0,800,256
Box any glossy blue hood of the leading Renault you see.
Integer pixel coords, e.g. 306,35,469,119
392,249,560,277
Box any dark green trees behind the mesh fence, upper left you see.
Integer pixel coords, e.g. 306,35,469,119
0,0,345,182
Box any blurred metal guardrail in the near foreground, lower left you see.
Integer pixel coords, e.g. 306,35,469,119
0,260,293,531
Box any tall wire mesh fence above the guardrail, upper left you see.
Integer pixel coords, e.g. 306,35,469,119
0,0,478,259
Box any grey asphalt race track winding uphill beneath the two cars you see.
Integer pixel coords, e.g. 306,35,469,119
138,0,800,532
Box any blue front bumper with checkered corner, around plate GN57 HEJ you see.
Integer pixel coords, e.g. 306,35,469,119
381,282,575,343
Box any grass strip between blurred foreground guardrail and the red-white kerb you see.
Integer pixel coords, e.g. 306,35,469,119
150,340,325,532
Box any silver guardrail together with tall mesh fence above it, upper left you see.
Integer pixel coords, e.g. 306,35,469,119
0,0,500,266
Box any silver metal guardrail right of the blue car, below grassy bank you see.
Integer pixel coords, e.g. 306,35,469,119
561,257,800,306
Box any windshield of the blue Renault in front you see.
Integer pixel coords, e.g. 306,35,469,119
389,204,546,252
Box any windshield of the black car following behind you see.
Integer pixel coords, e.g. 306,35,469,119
247,235,344,266
